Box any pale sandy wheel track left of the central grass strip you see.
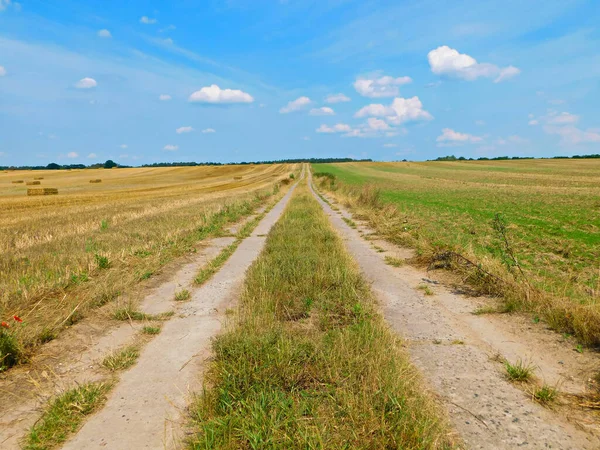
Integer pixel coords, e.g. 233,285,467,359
64,181,294,450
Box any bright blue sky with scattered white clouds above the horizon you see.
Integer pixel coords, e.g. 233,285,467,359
0,0,600,165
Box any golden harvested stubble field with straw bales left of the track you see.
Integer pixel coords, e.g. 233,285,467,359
0,165,294,368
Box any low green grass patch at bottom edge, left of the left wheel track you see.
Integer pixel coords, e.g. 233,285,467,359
23,383,111,450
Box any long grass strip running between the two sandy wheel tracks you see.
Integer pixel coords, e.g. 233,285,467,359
189,181,452,449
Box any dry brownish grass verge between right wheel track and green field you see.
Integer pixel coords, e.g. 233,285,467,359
311,167,600,347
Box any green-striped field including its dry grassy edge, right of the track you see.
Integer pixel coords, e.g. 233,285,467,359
313,160,600,346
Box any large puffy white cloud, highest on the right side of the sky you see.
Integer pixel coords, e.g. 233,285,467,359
427,45,521,83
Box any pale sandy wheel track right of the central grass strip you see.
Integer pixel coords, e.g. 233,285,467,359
311,175,600,449
